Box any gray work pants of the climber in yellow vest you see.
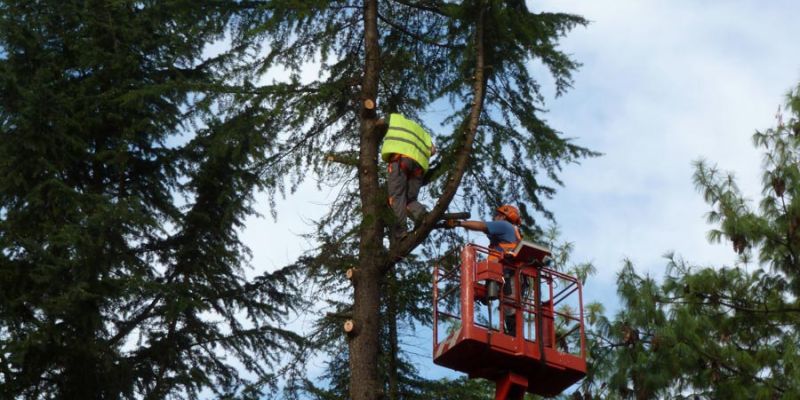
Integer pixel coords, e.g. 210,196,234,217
388,157,426,235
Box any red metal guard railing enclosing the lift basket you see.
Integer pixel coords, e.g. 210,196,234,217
433,244,586,359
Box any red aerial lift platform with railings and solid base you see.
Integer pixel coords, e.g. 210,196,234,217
433,241,586,400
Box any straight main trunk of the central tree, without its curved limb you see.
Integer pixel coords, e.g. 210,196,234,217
350,0,384,400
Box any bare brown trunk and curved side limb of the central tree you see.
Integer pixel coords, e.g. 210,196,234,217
349,0,488,400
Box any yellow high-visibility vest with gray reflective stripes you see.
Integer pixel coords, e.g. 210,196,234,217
381,114,433,171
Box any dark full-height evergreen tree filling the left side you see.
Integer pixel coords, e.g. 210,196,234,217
0,0,304,399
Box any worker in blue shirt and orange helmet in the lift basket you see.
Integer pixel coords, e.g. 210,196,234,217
445,204,522,336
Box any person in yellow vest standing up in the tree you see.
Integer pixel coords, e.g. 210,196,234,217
381,114,436,240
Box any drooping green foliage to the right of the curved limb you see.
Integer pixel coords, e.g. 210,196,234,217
454,1,598,225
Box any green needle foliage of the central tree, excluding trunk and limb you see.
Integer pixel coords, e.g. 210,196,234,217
219,0,596,399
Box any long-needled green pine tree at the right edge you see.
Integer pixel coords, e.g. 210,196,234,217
582,86,800,399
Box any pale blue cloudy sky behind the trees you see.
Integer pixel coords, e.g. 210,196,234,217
244,0,800,382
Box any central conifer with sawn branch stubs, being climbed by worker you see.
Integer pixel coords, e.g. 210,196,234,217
231,0,593,400
